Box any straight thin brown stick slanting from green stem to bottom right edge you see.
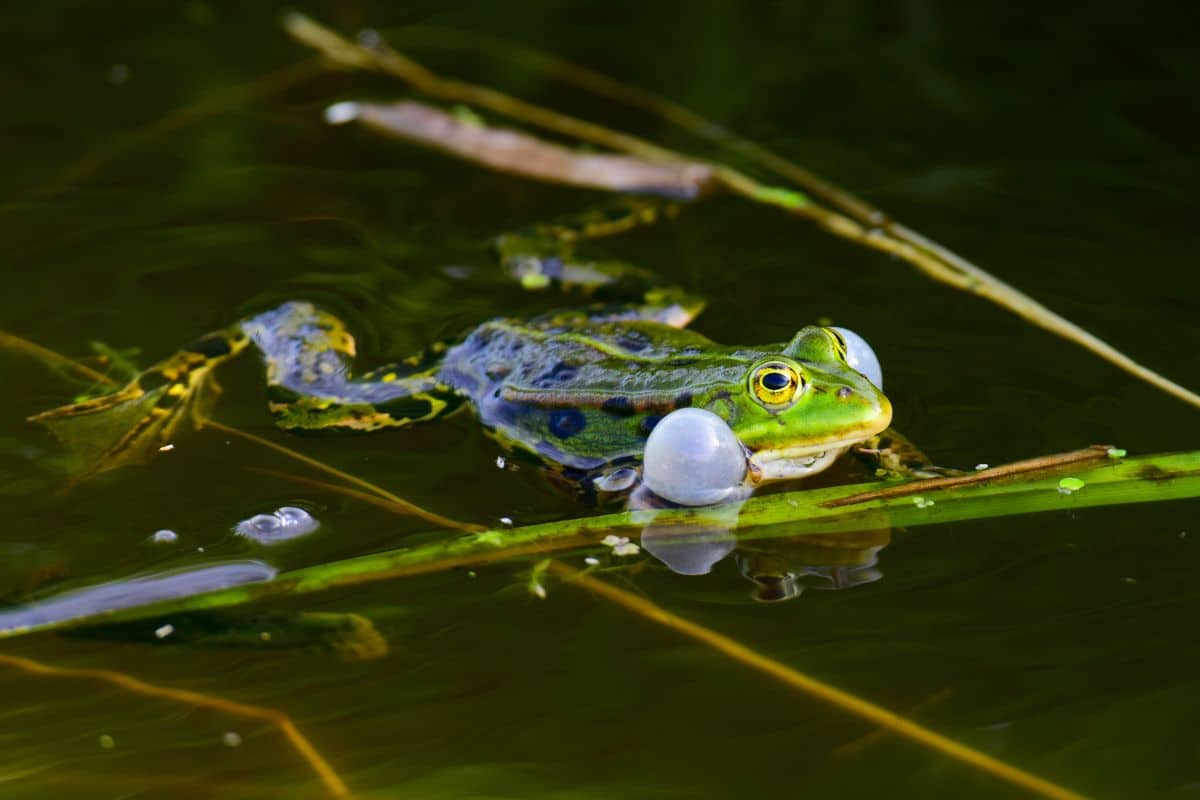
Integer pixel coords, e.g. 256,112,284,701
550,561,1084,800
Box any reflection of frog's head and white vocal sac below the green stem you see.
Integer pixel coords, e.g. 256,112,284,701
642,506,892,602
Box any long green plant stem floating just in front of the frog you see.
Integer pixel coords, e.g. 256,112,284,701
0,451,1200,638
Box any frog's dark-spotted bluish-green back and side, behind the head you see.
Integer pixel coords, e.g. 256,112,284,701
438,314,761,471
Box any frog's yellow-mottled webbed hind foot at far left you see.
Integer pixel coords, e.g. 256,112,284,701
30,329,247,474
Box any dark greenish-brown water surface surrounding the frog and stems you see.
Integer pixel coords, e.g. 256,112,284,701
0,0,1200,799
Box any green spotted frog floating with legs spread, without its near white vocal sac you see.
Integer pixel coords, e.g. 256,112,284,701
34,199,892,500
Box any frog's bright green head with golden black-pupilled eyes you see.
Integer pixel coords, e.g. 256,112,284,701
722,326,892,482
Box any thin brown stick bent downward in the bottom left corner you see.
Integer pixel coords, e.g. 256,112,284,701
0,654,350,798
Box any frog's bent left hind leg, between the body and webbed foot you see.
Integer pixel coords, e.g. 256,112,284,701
242,302,462,431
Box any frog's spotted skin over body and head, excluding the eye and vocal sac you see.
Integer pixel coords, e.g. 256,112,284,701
437,317,890,473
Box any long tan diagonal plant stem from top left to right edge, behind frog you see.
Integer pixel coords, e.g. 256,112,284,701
283,13,1200,408
